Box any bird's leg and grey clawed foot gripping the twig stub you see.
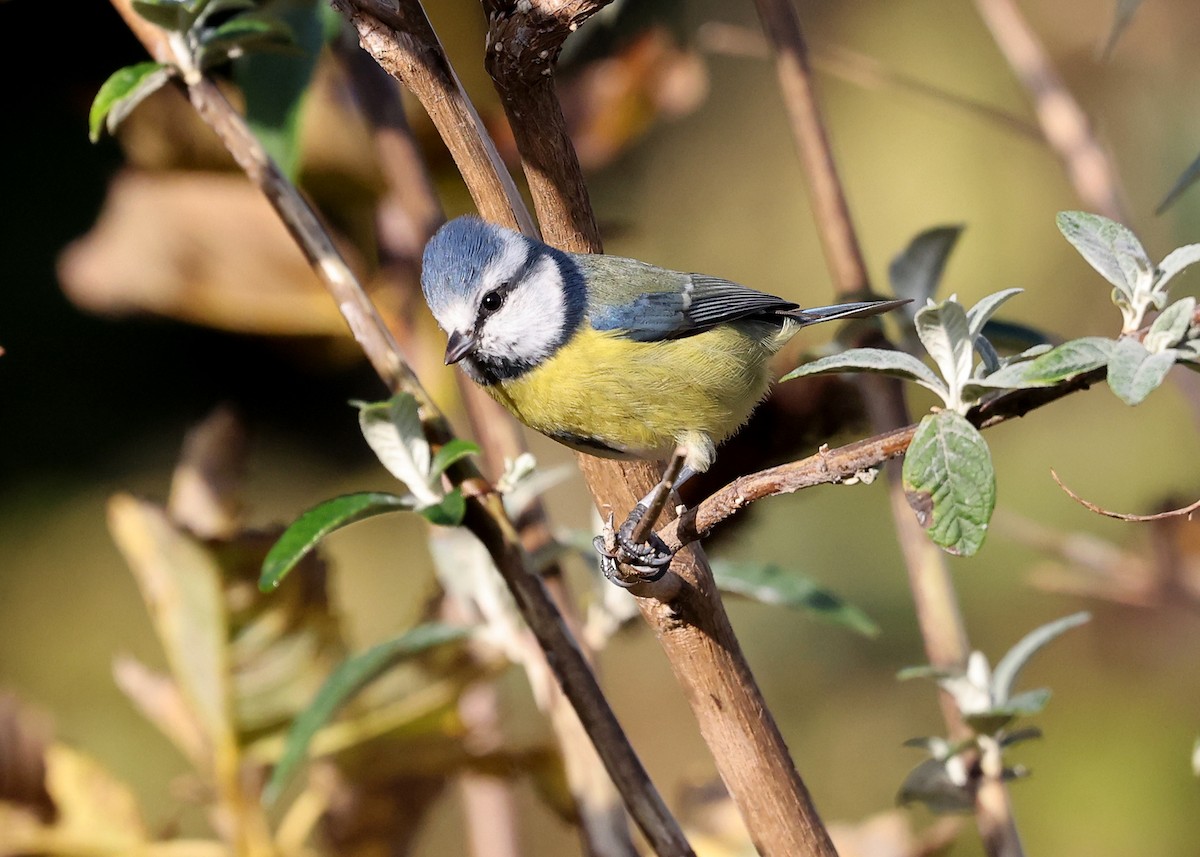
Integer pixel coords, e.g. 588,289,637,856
593,448,694,586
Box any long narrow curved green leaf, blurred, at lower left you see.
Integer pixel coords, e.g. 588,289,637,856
263,623,468,804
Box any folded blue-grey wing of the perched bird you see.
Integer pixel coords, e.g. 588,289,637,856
588,274,799,342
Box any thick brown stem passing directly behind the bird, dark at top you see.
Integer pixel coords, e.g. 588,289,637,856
485,0,833,857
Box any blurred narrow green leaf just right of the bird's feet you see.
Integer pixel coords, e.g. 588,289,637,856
713,562,880,637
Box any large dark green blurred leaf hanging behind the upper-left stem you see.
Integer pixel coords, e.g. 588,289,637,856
234,0,329,179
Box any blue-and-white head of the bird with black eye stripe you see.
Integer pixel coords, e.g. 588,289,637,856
421,217,587,383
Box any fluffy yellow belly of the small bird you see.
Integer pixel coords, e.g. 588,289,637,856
488,325,774,457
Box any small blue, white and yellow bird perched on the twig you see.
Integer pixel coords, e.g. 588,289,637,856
421,216,907,565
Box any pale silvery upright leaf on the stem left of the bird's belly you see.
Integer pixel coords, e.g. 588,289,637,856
355,392,443,507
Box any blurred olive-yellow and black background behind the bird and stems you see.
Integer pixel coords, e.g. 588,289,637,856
0,0,1200,857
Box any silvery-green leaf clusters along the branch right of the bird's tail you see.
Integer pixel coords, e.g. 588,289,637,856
784,211,1200,556
